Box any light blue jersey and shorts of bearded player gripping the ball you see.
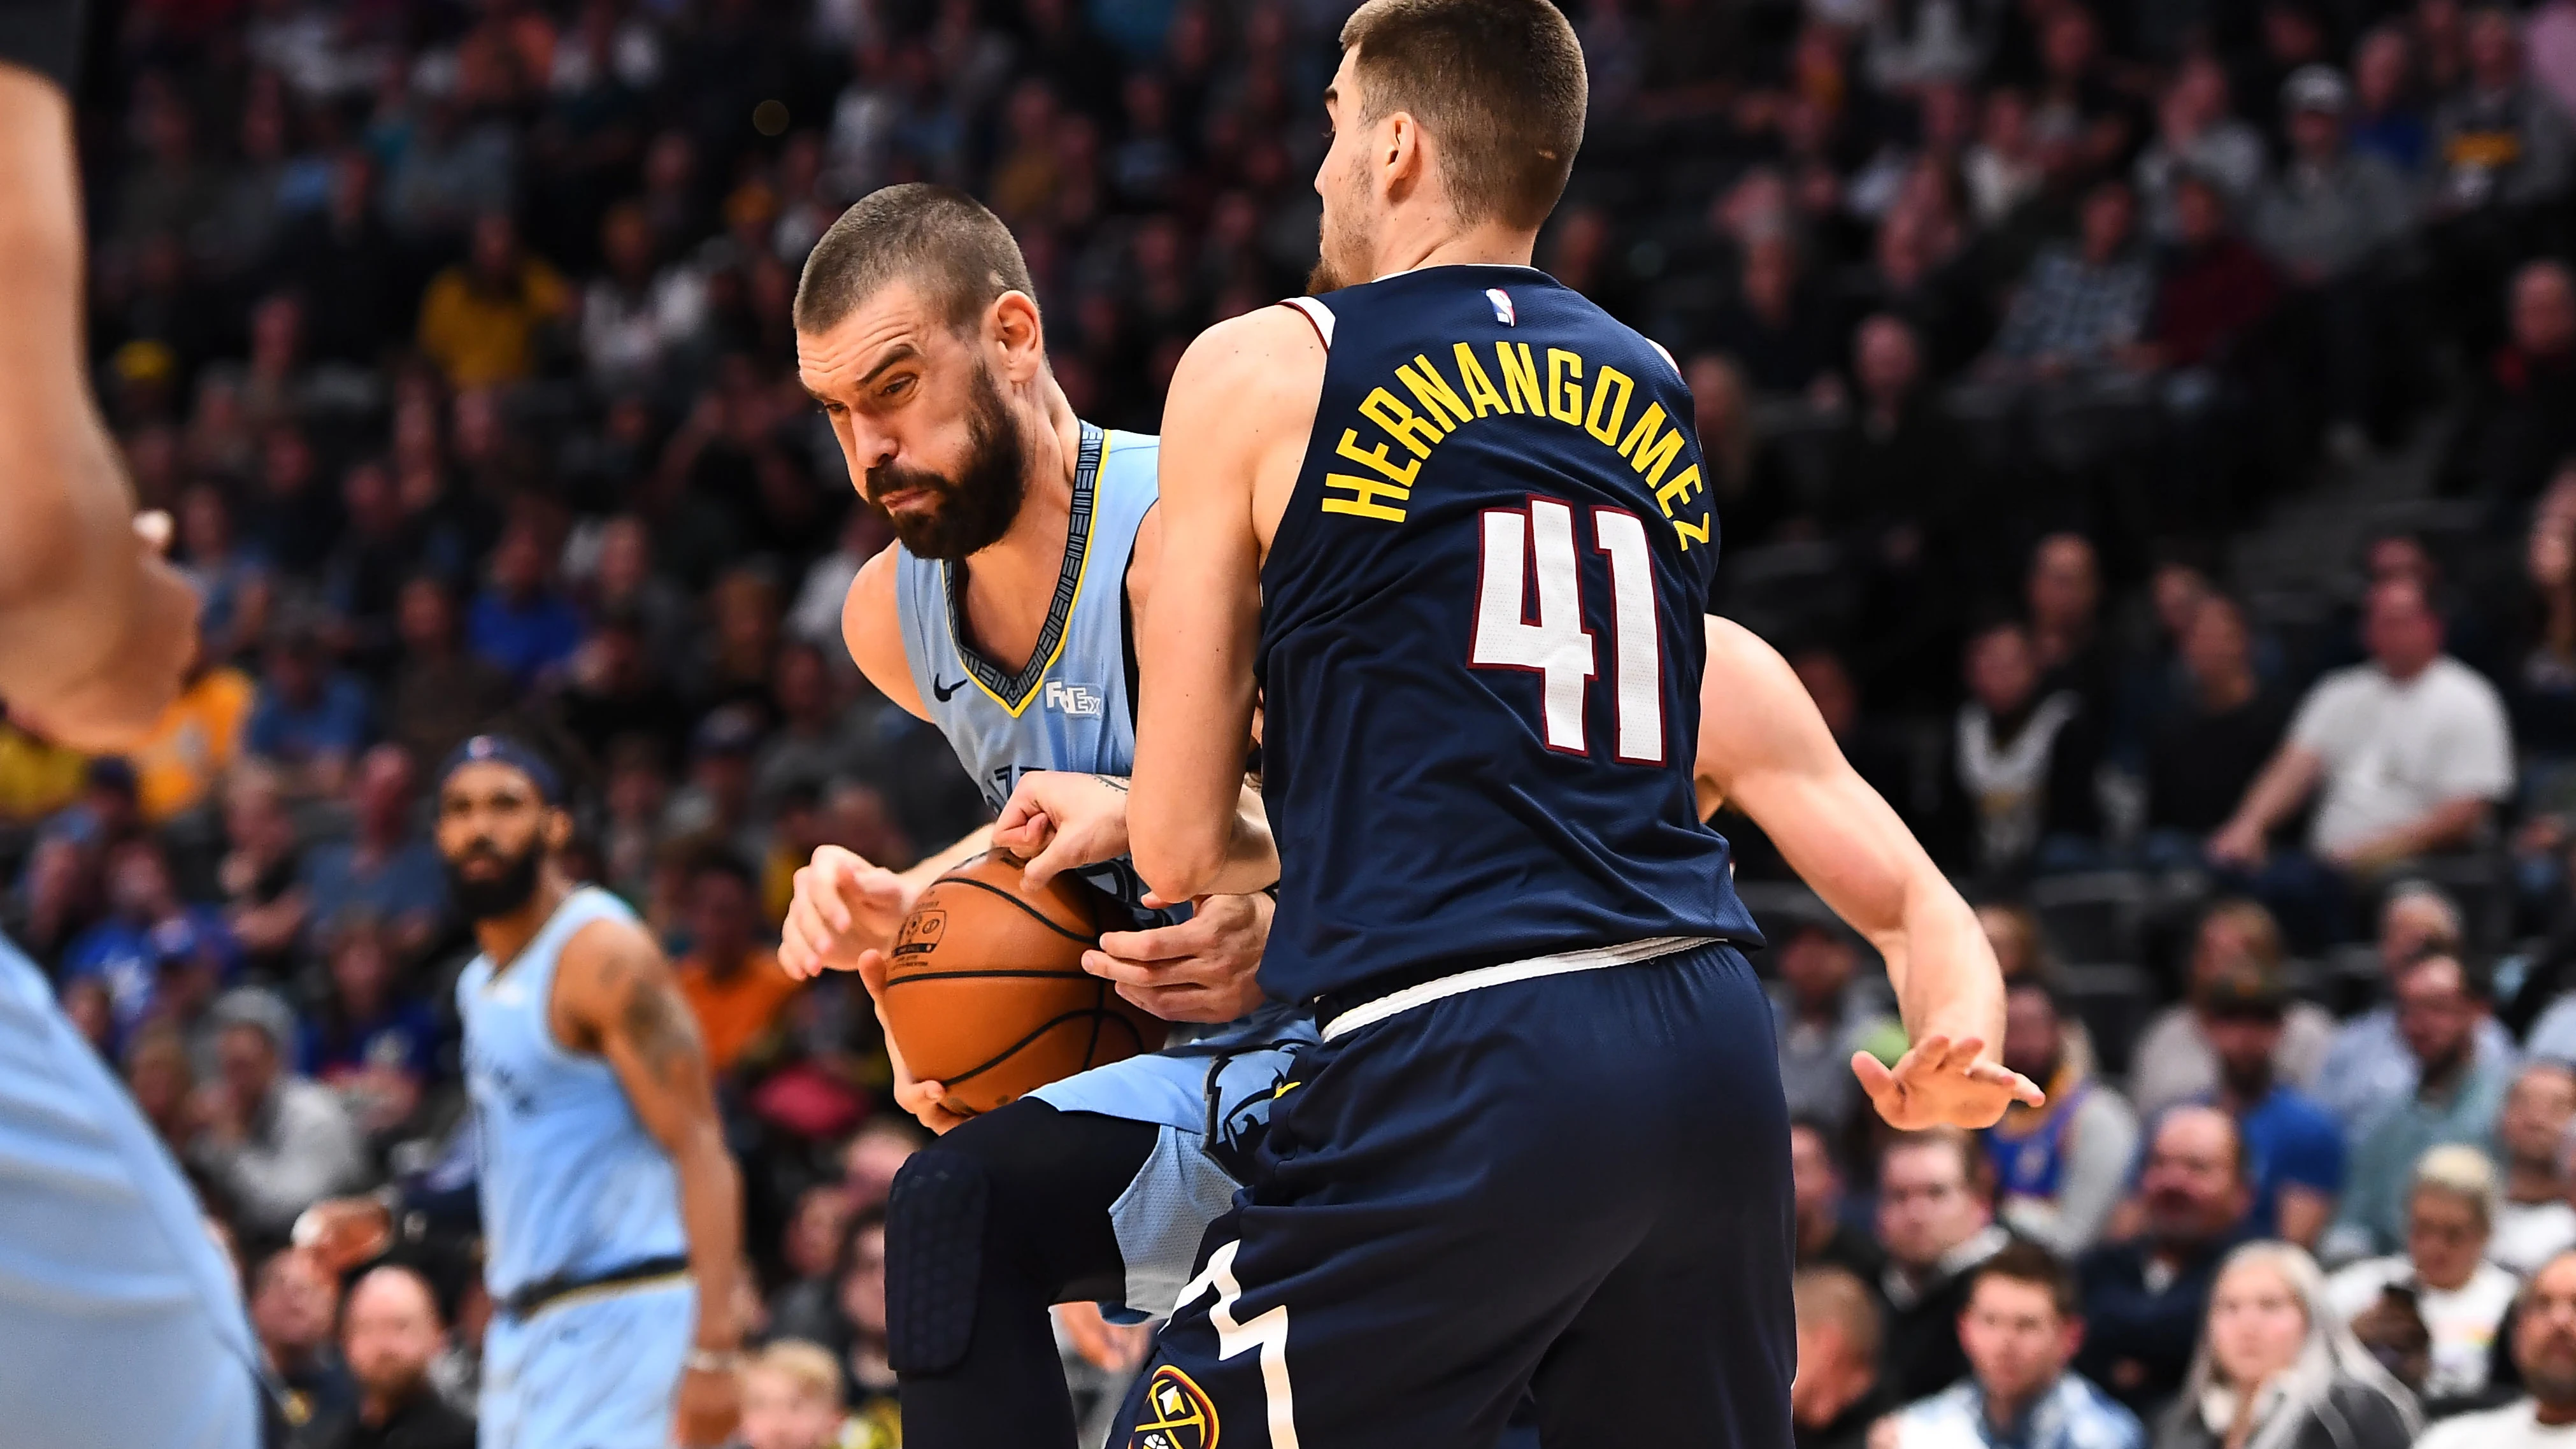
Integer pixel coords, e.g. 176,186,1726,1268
894,422,1313,1315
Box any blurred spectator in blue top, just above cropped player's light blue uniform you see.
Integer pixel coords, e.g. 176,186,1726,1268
62,836,242,1068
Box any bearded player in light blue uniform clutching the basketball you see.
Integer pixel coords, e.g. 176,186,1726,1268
780,185,1313,1449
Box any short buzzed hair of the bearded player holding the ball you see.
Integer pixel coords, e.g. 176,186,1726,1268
796,183,1038,332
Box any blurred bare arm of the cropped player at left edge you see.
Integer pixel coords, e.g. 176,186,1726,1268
0,64,196,749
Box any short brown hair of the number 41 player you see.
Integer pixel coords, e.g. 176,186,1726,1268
1342,0,1589,229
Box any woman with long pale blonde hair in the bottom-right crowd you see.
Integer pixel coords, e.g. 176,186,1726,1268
2156,1243,2419,1449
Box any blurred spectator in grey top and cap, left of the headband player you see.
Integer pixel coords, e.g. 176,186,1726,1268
188,986,366,1241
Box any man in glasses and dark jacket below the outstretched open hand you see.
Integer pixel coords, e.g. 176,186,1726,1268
1878,1127,2012,1403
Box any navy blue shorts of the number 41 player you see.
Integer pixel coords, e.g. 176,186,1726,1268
1113,945,1796,1449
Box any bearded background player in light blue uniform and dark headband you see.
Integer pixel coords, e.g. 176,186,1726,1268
438,736,742,1449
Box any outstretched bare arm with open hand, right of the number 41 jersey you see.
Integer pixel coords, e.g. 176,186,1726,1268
1698,618,2038,1127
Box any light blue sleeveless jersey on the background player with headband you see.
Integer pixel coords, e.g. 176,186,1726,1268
456,885,688,1300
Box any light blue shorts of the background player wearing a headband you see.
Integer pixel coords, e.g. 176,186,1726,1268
476,1279,698,1449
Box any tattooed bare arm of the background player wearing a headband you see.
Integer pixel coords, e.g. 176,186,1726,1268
557,922,742,1444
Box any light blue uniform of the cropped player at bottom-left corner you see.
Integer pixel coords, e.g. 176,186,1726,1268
0,942,260,1449
